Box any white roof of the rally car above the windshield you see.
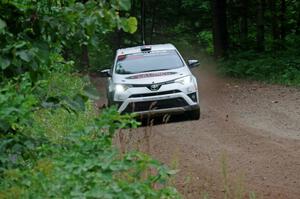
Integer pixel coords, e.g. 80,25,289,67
117,44,176,56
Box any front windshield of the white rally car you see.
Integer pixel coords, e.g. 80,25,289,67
115,50,183,74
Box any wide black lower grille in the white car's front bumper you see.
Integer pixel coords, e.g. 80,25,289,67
122,97,188,113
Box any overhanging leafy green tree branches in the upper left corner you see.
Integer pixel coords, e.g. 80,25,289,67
0,0,137,75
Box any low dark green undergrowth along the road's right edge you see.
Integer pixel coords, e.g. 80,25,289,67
219,51,300,85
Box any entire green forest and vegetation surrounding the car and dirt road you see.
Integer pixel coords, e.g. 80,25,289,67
0,0,300,198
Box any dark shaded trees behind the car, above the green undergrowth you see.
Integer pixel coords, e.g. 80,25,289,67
114,0,300,56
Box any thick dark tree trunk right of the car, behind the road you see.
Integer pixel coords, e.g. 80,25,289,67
212,0,228,57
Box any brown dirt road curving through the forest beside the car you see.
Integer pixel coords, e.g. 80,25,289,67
95,69,300,199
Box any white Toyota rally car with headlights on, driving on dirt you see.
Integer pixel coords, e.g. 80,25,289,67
101,44,200,119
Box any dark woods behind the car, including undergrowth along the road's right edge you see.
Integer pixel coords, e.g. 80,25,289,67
79,0,300,84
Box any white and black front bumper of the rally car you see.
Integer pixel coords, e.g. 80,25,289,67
112,80,199,115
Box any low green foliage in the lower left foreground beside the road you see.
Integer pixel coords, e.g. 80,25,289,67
0,104,179,198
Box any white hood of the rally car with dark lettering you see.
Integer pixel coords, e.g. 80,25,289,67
113,67,191,84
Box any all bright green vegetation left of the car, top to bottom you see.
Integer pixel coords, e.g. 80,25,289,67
0,0,180,198
